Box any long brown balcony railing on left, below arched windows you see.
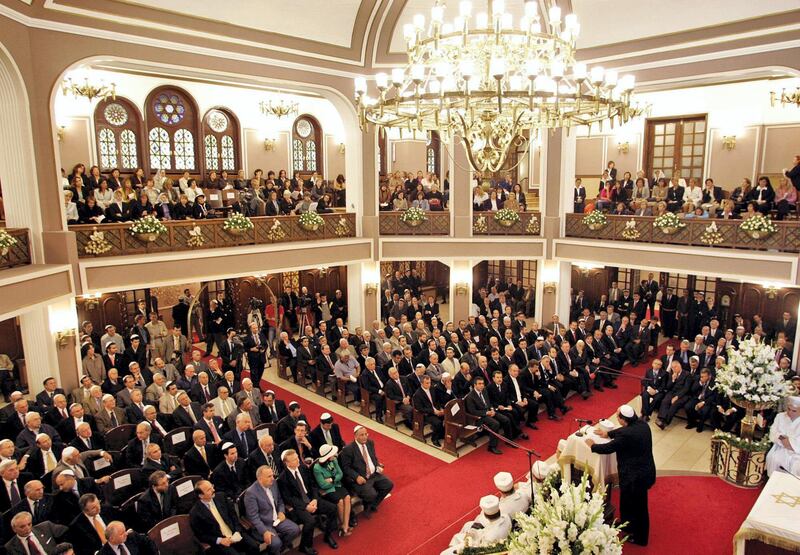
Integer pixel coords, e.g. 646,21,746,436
69,213,356,258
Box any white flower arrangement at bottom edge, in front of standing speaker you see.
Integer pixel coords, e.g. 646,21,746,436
508,475,625,555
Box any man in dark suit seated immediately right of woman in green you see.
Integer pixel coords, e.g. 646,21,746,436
339,425,394,516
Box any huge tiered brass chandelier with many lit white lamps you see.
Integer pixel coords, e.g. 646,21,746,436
355,0,641,174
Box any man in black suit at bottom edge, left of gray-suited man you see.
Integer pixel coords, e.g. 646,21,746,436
189,480,258,555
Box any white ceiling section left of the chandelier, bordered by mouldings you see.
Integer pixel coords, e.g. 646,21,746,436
124,0,361,47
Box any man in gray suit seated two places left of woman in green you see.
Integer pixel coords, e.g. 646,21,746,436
244,465,300,555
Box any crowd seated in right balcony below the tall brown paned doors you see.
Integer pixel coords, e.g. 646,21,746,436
573,156,800,220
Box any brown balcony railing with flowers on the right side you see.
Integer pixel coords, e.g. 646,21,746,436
566,214,800,252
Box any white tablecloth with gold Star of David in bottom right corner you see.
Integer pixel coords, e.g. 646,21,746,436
734,472,800,555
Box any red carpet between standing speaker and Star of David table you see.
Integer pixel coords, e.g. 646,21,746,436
614,476,761,555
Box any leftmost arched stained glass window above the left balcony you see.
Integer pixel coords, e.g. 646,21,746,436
94,96,141,173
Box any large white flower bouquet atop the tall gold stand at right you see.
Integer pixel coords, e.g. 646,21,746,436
715,338,787,405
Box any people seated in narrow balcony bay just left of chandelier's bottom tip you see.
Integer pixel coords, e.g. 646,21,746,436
378,171,450,212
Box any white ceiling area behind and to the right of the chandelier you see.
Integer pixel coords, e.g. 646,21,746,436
390,0,800,53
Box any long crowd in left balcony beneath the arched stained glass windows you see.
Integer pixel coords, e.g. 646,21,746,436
61,164,346,224
